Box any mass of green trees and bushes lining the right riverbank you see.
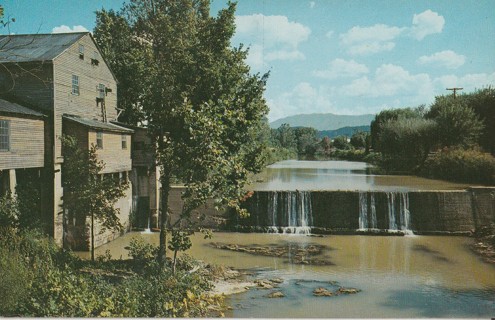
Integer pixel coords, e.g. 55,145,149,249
371,87,495,184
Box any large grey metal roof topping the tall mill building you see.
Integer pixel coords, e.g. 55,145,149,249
0,32,88,63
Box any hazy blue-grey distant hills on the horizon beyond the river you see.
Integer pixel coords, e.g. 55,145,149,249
270,113,375,131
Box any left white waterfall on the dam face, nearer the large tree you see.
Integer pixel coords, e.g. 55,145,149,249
267,191,313,234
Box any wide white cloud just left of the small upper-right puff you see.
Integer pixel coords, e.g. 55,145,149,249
340,24,405,55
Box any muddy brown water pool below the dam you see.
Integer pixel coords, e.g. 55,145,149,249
78,232,495,318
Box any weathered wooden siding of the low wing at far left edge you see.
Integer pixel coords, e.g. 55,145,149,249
0,115,45,170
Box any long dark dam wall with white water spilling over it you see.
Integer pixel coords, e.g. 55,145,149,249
236,188,495,234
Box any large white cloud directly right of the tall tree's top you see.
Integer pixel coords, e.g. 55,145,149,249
235,14,311,69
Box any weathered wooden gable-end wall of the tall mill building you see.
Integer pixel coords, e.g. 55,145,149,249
53,35,117,158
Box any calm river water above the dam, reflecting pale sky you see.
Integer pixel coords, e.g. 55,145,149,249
251,160,468,191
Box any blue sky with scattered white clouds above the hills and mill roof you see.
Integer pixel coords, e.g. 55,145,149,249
0,0,495,121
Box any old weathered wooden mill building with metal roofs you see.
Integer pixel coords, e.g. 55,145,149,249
0,32,160,250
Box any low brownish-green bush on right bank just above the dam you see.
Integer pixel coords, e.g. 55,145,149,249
423,148,495,185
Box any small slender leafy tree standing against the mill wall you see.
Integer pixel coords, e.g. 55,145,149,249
62,136,129,260
